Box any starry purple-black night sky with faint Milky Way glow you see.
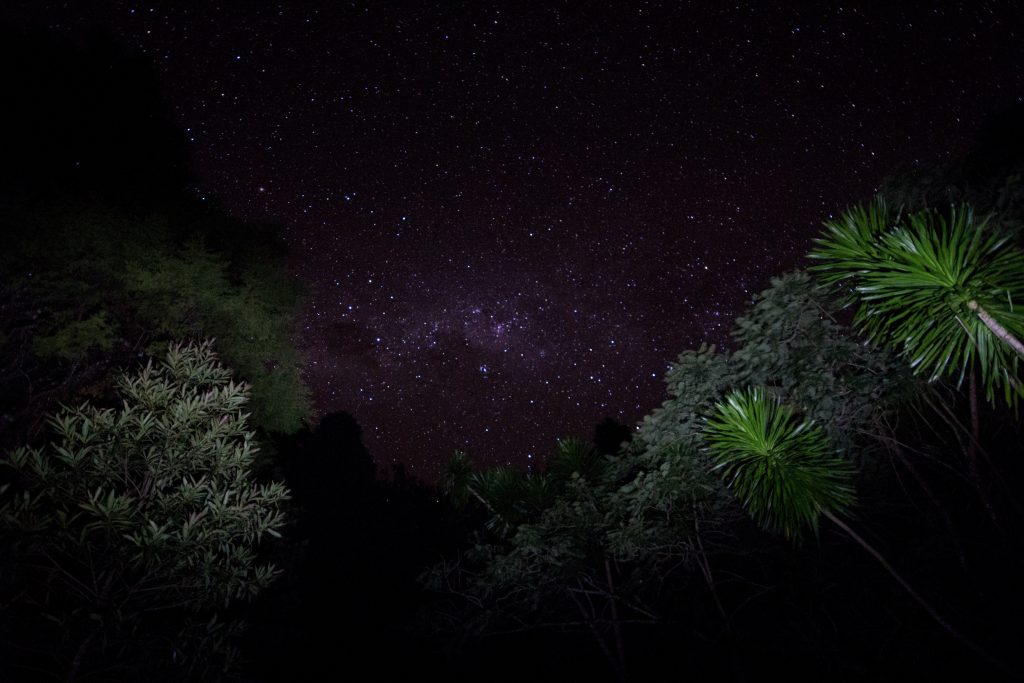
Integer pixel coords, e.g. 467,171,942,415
9,2,1024,478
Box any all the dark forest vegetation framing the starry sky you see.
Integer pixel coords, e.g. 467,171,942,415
0,24,1024,682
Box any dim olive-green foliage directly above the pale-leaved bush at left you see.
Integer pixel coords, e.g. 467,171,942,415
0,203,310,432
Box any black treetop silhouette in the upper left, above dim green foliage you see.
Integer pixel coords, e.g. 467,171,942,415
0,24,187,204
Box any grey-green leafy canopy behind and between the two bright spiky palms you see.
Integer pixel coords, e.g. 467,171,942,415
636,270,912,458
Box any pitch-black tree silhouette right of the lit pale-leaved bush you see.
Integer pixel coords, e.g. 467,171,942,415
246,413,456,681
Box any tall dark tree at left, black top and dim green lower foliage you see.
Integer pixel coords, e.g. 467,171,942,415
0,27,311,438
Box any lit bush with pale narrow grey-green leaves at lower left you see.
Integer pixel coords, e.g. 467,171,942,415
0,341,289,681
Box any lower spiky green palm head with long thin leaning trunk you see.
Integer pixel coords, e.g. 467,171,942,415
705,388,1001,668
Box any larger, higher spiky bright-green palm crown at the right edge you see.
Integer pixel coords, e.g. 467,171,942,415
809,198,1024,405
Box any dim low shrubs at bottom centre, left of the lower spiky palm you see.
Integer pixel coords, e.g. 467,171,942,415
425,439,728,668
